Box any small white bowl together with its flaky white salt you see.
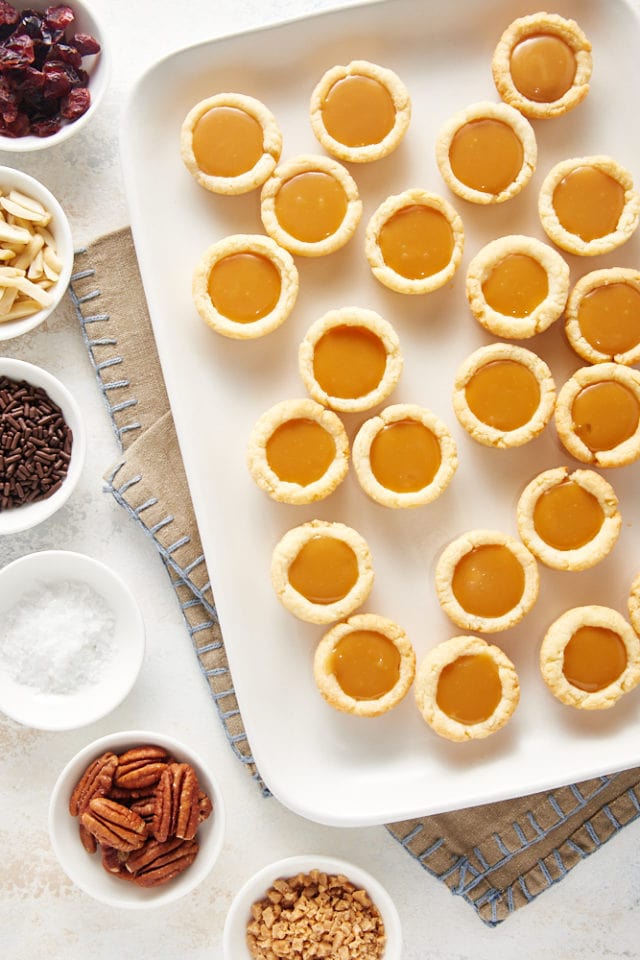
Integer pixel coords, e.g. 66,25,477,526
0,550,145,730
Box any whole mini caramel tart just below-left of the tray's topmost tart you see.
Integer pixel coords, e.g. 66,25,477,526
436,102,538,204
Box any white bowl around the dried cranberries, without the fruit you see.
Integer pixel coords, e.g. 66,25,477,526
0,0,111,153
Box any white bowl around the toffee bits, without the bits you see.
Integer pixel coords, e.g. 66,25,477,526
222,854,402,960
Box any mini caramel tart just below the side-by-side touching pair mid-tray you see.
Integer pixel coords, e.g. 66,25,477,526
271,520,373,623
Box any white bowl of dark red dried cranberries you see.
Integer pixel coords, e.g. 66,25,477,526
0,0,110,153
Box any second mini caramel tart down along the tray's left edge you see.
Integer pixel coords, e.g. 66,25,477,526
192,234,299,340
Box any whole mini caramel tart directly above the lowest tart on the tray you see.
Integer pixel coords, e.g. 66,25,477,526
435,530,539,633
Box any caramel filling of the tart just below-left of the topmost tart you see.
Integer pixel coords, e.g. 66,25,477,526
449,117,524,194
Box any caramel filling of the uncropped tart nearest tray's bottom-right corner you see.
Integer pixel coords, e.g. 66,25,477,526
562,627,627,693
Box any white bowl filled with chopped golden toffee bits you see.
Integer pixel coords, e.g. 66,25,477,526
223,854,402,960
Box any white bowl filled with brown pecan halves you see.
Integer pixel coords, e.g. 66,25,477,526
49,731,224,909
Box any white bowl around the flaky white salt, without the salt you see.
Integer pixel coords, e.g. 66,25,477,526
0,550,145,730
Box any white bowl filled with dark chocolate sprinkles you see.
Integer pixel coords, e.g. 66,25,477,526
0,357,86,535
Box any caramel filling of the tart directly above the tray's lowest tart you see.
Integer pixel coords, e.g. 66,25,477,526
451,543,524,617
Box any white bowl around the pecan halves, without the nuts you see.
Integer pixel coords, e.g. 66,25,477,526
49,730,225,910
